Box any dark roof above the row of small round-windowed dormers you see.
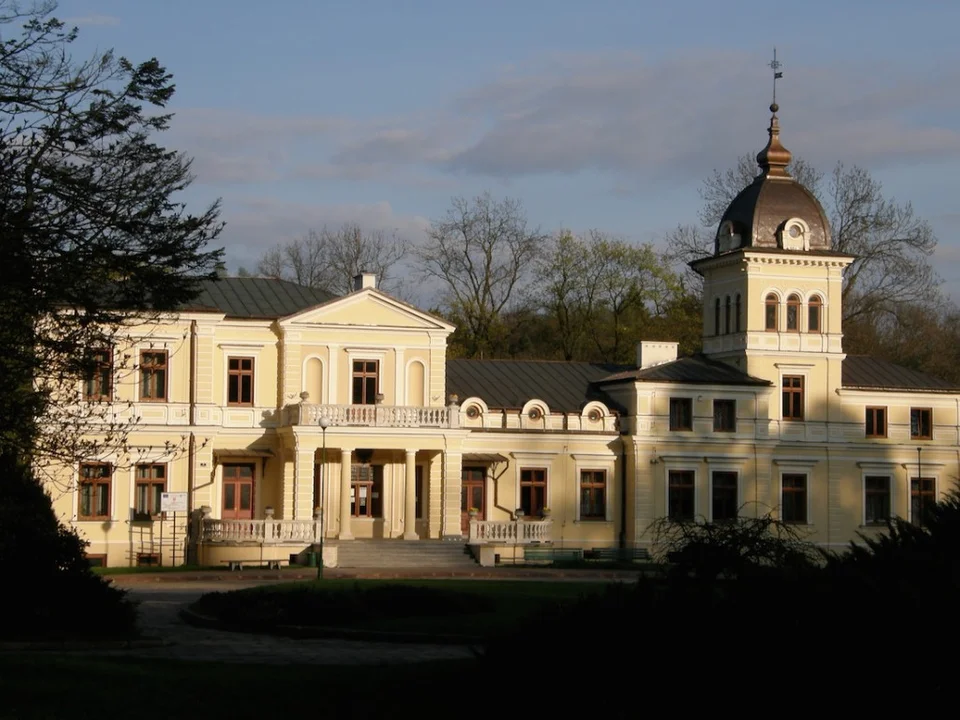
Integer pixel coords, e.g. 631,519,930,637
447,359,626,412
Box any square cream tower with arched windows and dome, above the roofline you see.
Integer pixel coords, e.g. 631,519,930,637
691,102,853,414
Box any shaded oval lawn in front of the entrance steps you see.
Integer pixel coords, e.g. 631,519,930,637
194,579,606,638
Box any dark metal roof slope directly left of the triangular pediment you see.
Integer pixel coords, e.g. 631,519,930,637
181,278,335,319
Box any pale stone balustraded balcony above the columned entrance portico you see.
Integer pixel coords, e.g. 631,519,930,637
281,403,460,429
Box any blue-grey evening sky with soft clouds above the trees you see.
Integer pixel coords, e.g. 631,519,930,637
57,0,960,300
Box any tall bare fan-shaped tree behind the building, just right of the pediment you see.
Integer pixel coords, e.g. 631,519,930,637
416,193,546,357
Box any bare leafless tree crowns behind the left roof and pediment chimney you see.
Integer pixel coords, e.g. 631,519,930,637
257,223,409,295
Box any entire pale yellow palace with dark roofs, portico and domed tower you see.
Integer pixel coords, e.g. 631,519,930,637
54,105,960,566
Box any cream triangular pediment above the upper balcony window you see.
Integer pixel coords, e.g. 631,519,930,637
280,288,455,332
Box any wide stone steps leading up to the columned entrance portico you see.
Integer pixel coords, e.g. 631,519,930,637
337,539,477,570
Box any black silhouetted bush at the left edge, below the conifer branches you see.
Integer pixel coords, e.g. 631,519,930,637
0,454,136,640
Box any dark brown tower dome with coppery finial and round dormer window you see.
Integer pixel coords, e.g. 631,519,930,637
714,103,831,255
